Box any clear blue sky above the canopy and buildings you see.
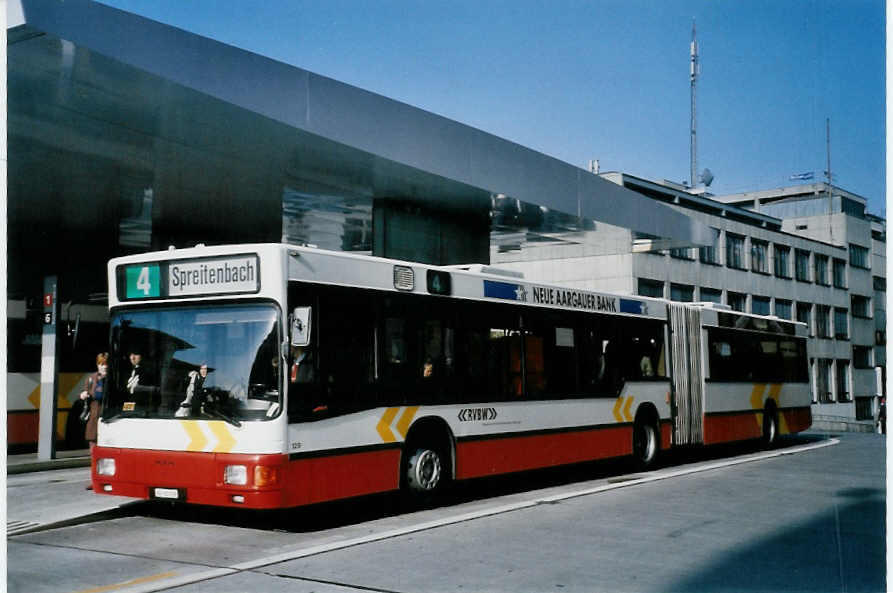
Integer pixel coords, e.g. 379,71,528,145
103,0,886,216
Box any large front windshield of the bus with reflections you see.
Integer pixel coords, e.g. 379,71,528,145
103,304,282,425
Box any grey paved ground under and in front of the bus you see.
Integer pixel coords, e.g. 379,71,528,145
7,435,886,593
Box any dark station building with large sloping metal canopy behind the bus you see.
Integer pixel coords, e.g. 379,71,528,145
6,0,710,450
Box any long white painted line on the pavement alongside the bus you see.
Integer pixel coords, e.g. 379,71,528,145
90,438,840,593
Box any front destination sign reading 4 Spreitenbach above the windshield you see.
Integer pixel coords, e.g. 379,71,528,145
117,254,260,300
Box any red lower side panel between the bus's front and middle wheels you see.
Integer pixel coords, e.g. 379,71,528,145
456,425,633,480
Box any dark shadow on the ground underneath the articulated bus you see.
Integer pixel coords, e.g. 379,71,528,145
126,435,827,533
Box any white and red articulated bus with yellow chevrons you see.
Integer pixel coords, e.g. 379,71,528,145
92,244,811,509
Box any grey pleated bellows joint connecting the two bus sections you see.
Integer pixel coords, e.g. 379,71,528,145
669,304,704,445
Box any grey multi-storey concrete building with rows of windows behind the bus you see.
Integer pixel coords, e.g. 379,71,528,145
491,173,887,430
